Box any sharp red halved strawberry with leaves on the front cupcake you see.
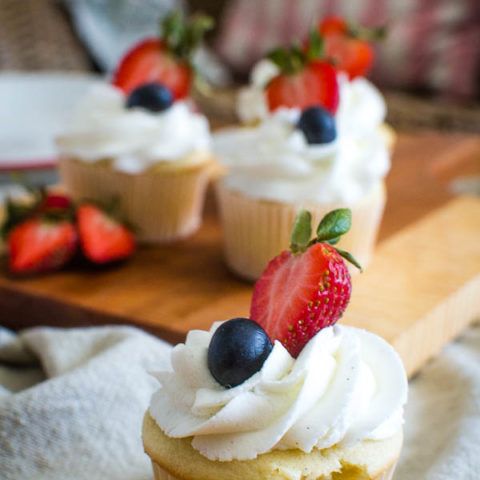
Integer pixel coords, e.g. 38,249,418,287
250,209,359,357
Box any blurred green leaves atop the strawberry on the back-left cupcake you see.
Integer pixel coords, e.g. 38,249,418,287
161,10,214,62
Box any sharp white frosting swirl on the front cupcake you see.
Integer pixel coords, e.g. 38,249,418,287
150,323,407,461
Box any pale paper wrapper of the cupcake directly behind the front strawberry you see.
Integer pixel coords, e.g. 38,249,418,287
216,179,386,280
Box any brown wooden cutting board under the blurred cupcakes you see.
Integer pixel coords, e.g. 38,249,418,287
0,133,480,374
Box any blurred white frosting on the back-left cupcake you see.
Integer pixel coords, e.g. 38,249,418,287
58,84,211,173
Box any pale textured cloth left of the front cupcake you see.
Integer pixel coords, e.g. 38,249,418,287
0,327,170,480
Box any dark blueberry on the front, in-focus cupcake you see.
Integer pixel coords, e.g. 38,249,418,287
208,318,272,388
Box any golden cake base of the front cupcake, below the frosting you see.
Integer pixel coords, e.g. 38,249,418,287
143,412,403,480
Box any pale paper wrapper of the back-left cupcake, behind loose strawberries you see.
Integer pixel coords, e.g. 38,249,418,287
59,158,210,243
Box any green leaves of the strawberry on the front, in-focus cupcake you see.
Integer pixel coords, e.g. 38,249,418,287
290,208,363,271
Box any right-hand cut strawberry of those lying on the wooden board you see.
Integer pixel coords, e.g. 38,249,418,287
77,204,135,264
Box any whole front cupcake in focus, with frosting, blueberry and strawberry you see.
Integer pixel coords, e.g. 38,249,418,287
143,214,407,480
